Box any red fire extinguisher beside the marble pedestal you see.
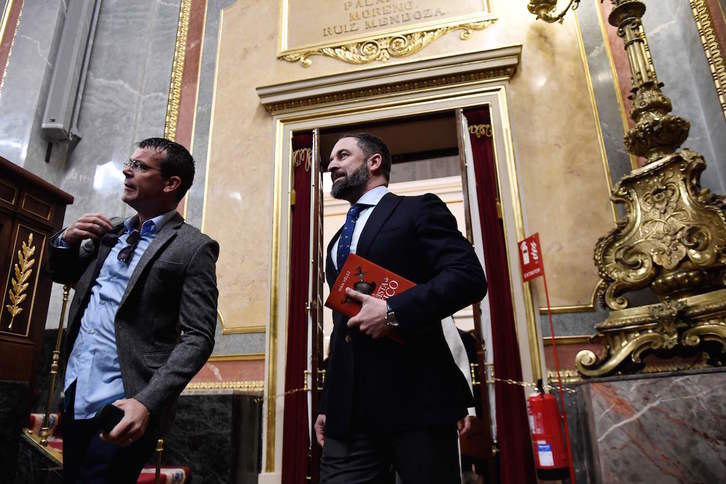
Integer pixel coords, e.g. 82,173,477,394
527,390,569,480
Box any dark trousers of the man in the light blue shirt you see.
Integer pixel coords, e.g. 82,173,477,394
61,384,158,484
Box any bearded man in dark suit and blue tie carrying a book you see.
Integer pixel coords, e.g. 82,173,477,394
315,133,486,484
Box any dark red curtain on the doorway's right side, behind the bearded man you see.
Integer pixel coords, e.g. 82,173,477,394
464,107,537,484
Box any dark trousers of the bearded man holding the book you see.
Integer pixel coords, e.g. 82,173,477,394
320,425,461,484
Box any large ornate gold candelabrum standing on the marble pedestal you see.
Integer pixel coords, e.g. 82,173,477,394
530,0,726,376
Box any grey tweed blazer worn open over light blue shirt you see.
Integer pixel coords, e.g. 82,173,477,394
48,214,219,431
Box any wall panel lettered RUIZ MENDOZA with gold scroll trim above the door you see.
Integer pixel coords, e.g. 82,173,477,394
278,0,495,67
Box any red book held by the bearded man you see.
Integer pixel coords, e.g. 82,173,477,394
325,254,416,317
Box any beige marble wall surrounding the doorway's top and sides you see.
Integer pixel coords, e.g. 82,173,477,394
204,0,613,328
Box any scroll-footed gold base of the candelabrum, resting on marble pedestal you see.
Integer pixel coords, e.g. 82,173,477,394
575,289,726,377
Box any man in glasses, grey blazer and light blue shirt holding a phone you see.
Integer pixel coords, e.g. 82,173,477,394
49,138,219,483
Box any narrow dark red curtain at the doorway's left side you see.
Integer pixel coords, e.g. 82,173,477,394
282,132,313,484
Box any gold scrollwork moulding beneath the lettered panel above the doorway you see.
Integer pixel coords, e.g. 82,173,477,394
280,19,496,67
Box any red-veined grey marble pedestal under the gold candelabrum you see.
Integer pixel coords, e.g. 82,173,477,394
578,369,726,484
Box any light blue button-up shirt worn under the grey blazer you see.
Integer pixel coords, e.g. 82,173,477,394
59,210,176,420
